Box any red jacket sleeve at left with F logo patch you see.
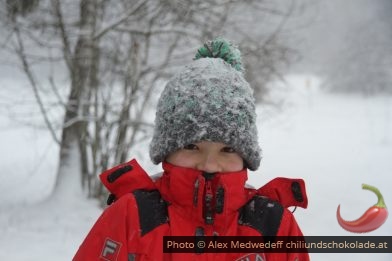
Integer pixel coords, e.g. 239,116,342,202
72,194,136,261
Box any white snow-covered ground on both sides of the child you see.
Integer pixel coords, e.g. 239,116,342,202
0,76,392,261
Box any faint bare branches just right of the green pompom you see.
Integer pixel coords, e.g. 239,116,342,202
220,1,303,103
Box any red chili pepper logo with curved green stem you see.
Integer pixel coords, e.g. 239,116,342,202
336,184,388,233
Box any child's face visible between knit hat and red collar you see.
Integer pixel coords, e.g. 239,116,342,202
166,141,244,173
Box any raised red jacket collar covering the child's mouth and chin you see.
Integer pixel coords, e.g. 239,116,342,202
156,162,250,224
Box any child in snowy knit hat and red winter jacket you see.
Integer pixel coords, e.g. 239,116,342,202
73,38,309,261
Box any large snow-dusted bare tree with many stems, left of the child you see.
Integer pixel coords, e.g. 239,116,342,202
1,0,298,201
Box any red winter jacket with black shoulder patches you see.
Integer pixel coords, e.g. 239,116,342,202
73,160,309,261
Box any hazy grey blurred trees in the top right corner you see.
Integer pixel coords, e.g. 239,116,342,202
318,0,392,95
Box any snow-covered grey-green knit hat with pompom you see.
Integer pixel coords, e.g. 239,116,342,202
150,38,261,170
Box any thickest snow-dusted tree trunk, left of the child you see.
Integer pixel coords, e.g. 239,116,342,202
54,0,96,198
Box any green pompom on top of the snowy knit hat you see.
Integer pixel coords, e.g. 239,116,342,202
195,38,244,72
